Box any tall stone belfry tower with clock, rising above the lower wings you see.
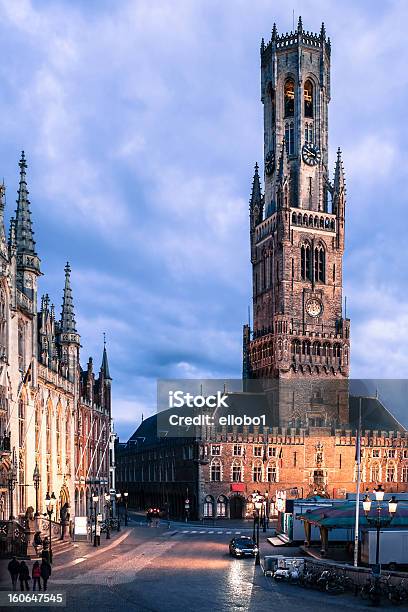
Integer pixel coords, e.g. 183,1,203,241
244,18,350,427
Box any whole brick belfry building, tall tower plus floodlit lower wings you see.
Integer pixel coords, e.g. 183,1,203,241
117,19,408,518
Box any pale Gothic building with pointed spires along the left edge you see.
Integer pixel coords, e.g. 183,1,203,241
0,152,111,519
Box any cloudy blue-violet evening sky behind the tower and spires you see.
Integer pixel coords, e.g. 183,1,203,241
0,0,408,440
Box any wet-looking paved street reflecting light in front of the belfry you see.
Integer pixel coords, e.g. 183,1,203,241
0,525,394,612
